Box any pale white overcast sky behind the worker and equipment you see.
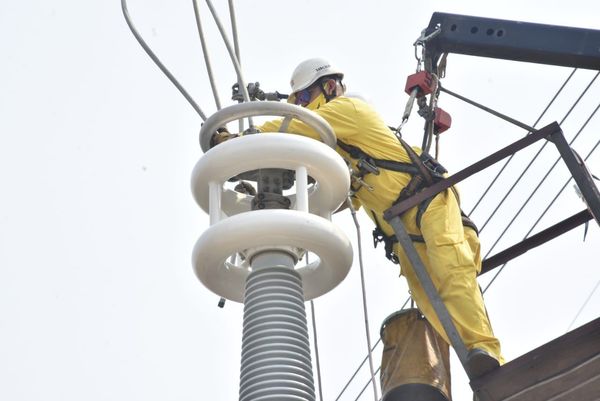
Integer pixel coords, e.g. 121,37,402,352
0,0,600,401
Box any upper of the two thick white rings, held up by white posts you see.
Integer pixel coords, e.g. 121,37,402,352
191,133,350,218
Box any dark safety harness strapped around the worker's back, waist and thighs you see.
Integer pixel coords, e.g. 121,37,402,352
337,129,478,264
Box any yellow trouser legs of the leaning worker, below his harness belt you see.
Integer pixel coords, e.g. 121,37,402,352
394,190,504,364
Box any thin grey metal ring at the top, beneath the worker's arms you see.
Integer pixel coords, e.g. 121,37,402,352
200,102,336,152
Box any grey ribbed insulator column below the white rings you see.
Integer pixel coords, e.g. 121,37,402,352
239,264,315,401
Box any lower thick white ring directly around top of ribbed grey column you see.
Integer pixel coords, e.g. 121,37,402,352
192,209,352,302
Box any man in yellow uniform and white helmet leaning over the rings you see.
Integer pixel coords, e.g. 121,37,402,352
211,58,503,378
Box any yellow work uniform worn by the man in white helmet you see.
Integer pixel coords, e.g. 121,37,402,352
259,95,503,363
